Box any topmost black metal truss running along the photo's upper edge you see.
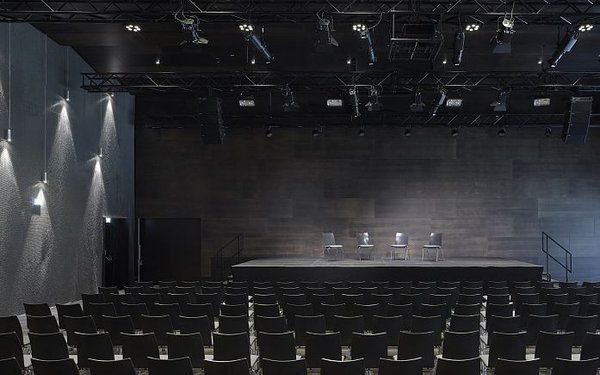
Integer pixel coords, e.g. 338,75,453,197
0,0,600,25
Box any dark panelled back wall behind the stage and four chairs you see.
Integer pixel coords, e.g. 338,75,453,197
136,120,600,280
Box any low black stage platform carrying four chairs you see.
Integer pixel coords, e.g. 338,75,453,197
232,258,543,281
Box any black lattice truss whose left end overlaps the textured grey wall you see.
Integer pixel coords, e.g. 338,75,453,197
81,71,600,94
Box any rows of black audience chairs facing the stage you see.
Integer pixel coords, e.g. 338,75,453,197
0,280,600,375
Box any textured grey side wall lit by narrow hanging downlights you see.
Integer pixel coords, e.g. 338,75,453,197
0,24,134,315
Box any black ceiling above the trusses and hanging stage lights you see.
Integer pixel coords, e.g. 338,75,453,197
0,0,600,126
